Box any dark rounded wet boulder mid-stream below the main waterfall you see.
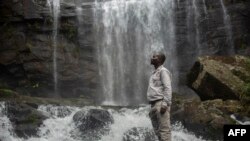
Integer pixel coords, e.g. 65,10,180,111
73,109,114,140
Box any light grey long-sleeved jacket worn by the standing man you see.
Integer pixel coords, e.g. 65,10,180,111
147,66,172,106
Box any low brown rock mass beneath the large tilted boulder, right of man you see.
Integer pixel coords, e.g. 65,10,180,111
171,96,250,140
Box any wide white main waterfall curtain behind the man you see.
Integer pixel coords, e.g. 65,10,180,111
94,0,178,105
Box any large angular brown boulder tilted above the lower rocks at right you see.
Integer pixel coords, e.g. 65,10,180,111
188,56,250,102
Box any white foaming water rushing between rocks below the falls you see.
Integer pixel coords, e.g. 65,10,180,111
0,102,206,141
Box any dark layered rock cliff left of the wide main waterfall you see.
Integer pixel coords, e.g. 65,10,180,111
0,0,98,97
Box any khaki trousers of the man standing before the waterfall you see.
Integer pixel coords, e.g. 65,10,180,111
149,101,171,141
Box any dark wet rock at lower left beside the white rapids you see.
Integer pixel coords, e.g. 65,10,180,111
7,102,47,138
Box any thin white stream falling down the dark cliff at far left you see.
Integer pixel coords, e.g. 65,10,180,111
47,0,60,96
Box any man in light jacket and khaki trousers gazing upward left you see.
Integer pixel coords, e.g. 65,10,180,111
147,53,172,141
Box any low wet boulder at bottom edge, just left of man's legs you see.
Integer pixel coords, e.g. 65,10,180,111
123,127,157,141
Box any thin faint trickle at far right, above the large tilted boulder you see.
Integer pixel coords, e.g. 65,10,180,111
220,0,235,55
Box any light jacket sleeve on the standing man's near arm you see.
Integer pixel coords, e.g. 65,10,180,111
161,70,172,106
